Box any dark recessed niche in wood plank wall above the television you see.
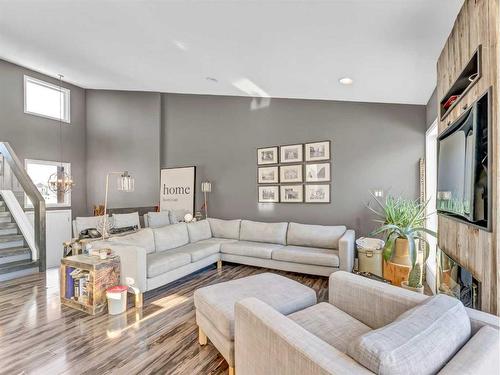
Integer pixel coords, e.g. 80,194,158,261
439,45,481,121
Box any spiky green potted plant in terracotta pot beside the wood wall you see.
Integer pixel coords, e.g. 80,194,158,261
368,195,436,290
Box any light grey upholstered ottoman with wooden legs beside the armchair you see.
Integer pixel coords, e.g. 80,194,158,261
194,273,316,374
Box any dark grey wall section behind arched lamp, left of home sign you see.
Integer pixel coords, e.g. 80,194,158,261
87,90,161,212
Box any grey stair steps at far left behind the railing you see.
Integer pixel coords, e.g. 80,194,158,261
0,196,39,281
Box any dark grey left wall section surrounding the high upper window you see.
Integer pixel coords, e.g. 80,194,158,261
0,60,87,216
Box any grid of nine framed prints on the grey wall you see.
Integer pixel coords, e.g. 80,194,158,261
257,141,332,203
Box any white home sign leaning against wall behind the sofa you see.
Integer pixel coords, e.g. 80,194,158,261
160,167,196,214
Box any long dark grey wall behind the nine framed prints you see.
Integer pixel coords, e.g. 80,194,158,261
161,94,426,235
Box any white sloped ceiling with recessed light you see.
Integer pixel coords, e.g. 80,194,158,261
0,0,463,104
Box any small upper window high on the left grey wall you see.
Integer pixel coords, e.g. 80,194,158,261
24,76,70,123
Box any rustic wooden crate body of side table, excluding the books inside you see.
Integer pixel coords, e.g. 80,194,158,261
60,255,120,315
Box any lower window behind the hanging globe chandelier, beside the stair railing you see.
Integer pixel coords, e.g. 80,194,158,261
24,159,71,207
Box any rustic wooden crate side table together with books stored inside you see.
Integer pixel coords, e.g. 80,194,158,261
60,255,120,315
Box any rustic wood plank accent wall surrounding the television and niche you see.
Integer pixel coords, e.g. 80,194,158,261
437,0,500,315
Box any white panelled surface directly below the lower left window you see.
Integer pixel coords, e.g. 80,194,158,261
26,210,71,268
